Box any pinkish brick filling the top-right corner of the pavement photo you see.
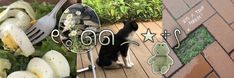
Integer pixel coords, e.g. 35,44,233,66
208,0,234,24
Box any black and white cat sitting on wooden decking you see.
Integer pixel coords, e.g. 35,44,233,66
96,20,138,68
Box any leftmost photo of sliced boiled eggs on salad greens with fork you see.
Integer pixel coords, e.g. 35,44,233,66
0,0,82,78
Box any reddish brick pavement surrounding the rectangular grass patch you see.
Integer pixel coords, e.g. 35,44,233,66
163,0,234,78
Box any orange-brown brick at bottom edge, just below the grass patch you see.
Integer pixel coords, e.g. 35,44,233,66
172,55,212,78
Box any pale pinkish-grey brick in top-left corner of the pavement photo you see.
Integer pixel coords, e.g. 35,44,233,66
163,0,189,18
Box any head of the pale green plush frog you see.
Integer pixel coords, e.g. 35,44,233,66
154,42,169,55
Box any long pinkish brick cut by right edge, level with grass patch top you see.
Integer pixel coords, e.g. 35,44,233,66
204,14,234,53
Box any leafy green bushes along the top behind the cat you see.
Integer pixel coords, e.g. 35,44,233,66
83,0,162,23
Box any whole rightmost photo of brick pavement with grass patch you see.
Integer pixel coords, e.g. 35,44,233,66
161,0,234,78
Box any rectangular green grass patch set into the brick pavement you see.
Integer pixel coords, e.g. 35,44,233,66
174,26,214,64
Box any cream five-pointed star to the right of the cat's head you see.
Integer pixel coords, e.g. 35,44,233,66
141,28,156,42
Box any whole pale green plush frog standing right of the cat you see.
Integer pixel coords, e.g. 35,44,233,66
148,42,173,74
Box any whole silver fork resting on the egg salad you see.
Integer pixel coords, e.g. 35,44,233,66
26,0,67,44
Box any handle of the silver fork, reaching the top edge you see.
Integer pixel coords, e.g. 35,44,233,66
50,0,67,18
